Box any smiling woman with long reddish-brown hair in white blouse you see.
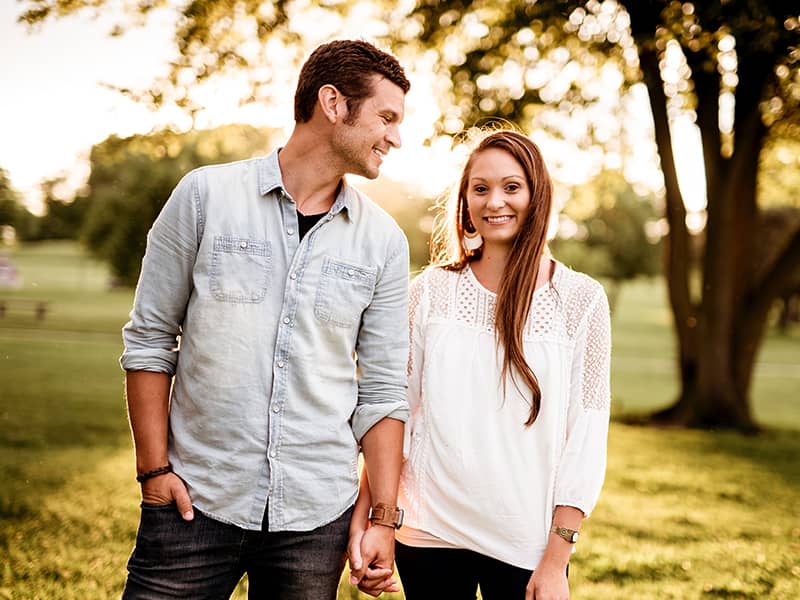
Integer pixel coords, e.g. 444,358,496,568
348,131,610,600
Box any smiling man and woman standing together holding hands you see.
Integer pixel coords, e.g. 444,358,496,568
121,40,610,600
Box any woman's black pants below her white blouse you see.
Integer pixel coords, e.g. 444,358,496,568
394,542,533,600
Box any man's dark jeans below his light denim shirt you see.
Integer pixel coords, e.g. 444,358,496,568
122,504,352,600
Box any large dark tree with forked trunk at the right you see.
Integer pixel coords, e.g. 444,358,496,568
626,1,800,429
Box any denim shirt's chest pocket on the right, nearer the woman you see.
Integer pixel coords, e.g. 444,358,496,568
314,256,378,328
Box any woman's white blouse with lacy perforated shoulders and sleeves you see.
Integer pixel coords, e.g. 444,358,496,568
397,263,611,569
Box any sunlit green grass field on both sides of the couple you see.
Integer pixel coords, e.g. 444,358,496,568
0,243,800,600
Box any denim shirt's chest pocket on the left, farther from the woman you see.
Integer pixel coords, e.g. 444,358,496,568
210,235,272,303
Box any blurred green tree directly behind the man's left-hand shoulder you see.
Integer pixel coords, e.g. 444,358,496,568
82,125,272,285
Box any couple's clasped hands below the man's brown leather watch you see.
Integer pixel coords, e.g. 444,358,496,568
347,525,400,597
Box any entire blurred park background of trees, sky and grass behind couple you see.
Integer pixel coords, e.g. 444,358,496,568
0,0,800,599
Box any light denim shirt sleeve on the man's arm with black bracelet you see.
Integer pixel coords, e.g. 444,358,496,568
120,172,202,375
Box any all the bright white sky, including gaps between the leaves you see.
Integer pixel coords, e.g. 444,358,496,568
0,0,704,216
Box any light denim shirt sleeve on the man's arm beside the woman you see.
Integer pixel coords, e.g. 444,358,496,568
352,231,408,443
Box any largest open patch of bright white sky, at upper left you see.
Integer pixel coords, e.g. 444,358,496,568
0,0,178,207
